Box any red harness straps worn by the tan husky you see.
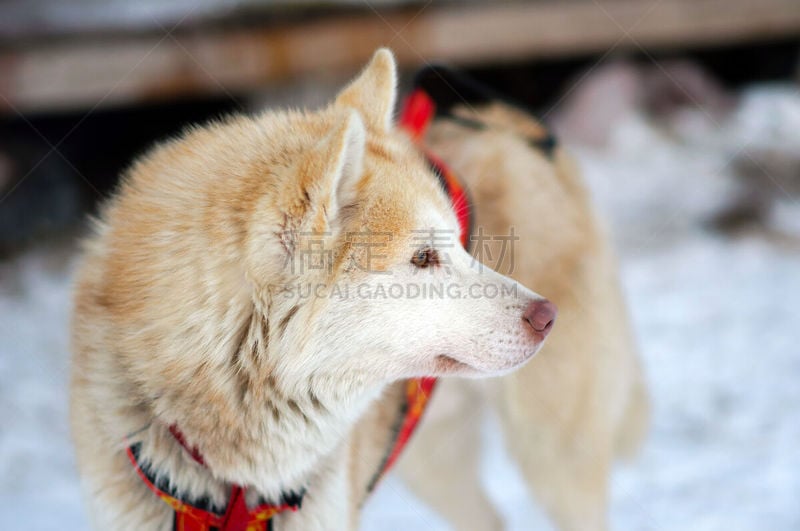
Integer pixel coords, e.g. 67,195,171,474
127,88,471,531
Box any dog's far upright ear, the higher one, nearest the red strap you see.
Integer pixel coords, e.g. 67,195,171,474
336,48,397,131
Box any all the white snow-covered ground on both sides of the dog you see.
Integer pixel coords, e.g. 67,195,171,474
0,88,800,530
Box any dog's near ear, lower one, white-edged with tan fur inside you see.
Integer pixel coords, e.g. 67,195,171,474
303,109,367,224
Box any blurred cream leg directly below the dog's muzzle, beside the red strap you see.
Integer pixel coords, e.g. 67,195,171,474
398,380,502,531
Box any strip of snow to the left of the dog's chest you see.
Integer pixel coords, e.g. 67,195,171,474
0,249,86,530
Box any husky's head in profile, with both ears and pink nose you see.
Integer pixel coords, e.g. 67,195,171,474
245,50,555,388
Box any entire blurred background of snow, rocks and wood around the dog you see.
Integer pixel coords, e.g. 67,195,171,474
0,0,800,530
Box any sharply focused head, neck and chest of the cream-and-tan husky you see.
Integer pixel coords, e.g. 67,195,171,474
71,50,556,530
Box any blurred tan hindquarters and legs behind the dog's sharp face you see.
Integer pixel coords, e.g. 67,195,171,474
401,104,648,530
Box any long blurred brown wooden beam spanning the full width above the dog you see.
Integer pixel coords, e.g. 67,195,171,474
0,0,800,112
